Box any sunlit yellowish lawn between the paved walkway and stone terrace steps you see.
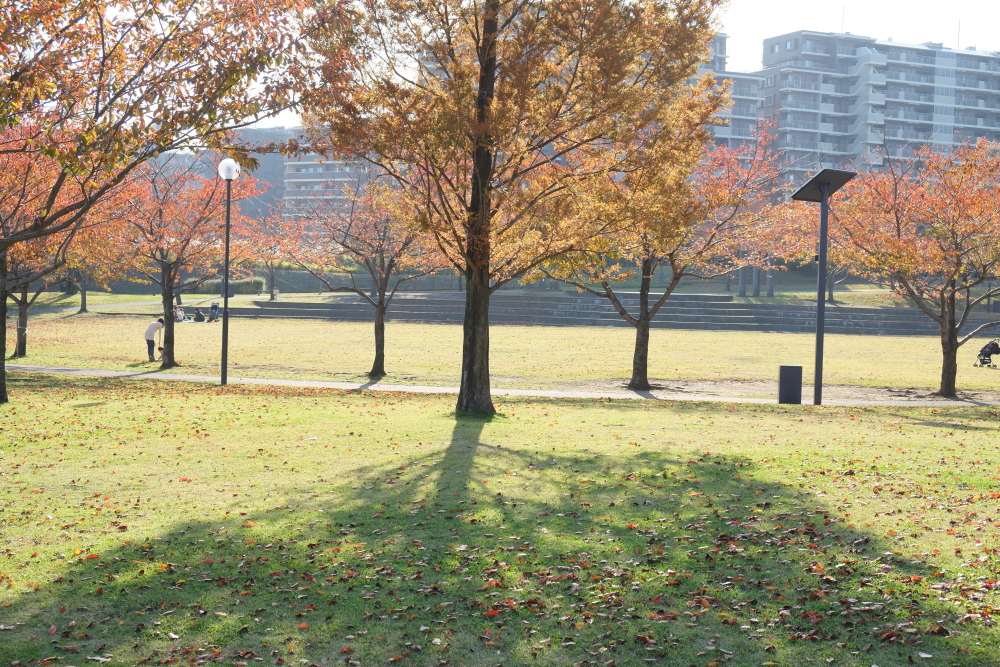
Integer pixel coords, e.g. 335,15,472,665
8,315,1000,391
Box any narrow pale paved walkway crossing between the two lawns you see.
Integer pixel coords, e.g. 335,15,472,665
7,363,1000,407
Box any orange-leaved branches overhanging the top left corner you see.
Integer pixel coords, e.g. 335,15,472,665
0,0,322,403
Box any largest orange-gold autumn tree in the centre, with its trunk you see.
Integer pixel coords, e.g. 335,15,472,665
303,0,722,413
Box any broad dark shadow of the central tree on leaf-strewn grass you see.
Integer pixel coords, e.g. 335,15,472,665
0,406,998,667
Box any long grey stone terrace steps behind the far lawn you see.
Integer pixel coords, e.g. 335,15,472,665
223,292,1000,336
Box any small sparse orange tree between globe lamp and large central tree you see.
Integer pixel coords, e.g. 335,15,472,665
286,171,446,378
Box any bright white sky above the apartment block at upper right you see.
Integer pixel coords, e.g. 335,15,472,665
721,0,1000,72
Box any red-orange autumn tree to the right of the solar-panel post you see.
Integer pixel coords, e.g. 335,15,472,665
832,141,1000,398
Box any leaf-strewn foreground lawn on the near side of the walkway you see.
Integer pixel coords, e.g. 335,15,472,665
0,374,1000,667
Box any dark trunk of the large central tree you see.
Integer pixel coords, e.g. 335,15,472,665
456,0,500,415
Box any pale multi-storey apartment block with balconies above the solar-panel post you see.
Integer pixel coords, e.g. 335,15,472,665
757,30,1000,180
